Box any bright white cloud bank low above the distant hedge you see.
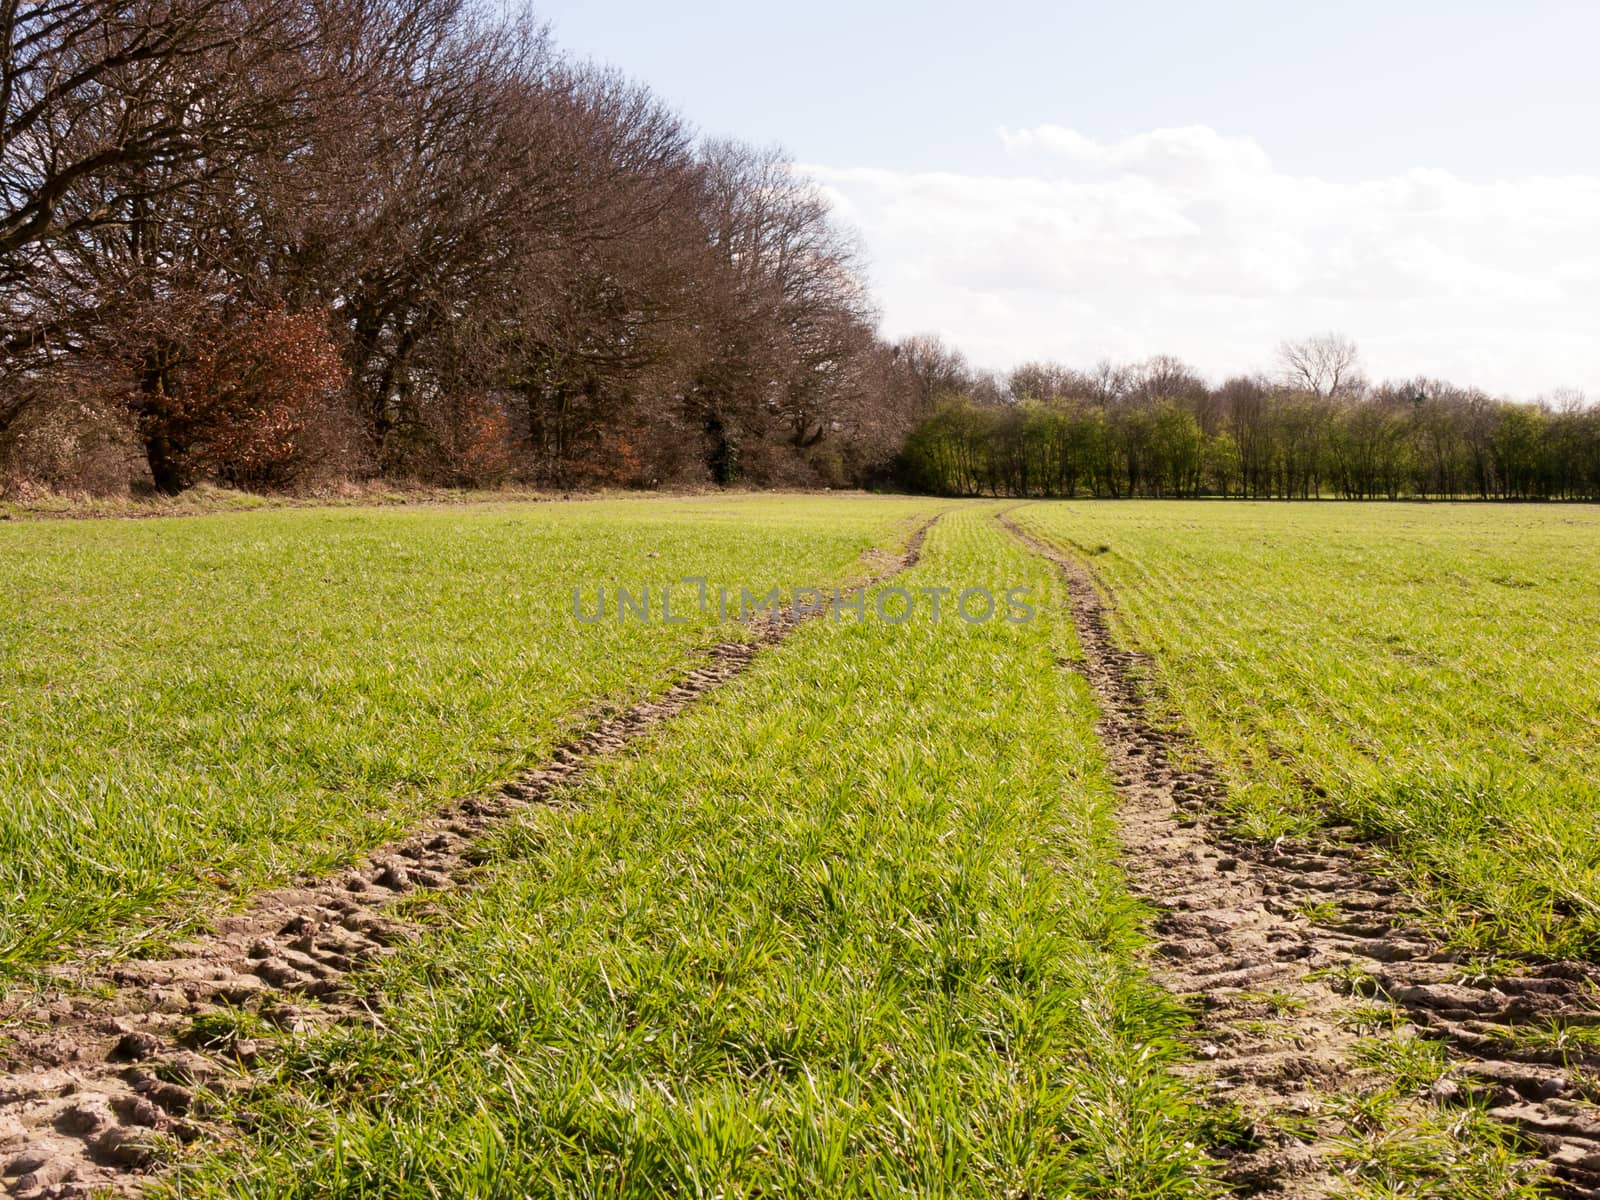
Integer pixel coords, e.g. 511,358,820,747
805,125,1600,395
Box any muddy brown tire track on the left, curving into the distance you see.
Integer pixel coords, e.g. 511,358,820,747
0,515,938,1200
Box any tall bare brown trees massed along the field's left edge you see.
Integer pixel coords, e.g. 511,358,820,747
0,0,918,493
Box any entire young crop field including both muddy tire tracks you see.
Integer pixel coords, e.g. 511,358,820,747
0,496,1600,1200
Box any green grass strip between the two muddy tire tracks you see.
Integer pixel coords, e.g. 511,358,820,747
170,509,1214,1198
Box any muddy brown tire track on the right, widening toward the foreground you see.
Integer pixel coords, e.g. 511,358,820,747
1000,515,1600,1198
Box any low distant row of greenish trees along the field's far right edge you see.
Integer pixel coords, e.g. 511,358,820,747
899,334,1600,499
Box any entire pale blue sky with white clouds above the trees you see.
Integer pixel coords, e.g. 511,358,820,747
538,0,1600,395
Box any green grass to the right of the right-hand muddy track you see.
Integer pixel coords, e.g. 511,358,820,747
1016,502,1600,960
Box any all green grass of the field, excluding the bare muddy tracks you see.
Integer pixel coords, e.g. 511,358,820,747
0,496,1600,1200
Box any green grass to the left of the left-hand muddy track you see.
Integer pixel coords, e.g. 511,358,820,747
0,496,926,979
